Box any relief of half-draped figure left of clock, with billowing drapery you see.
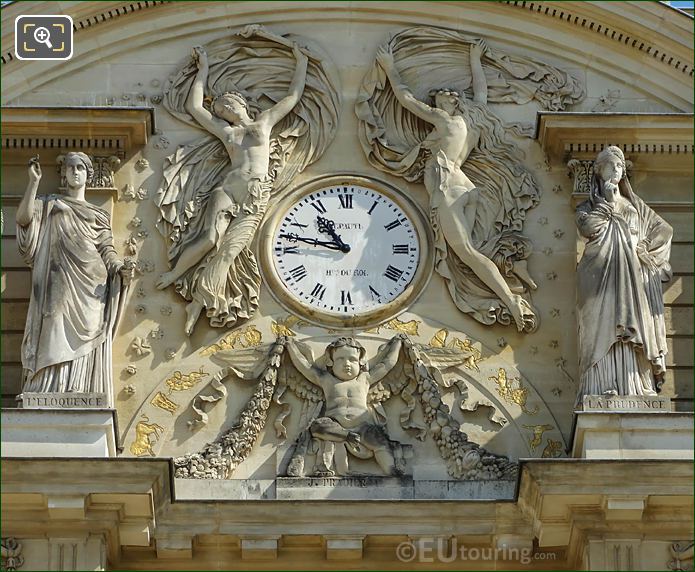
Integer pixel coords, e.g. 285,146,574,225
156,26,339,335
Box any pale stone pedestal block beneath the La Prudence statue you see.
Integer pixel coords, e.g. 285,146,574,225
572,410,693,459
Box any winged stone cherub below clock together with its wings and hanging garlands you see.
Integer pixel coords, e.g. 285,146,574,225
174,334,518,480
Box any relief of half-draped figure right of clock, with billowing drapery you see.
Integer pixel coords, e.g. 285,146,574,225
355,28,583,332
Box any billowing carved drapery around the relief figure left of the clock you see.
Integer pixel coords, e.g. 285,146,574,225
156,26,340,326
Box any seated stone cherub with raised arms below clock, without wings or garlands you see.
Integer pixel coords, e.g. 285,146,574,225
286,336,407,476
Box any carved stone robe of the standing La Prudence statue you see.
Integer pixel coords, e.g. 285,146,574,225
576,175,673,402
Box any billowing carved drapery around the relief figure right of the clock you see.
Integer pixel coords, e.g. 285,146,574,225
355,27,584,329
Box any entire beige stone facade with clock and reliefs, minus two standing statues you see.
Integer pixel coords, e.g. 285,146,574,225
1,1,693,570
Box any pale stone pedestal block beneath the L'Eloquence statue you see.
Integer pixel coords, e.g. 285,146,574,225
2,409,116,457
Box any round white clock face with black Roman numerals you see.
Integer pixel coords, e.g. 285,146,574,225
269,181,430,323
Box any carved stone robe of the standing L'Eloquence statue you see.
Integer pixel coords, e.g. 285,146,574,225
17,195,126,406
